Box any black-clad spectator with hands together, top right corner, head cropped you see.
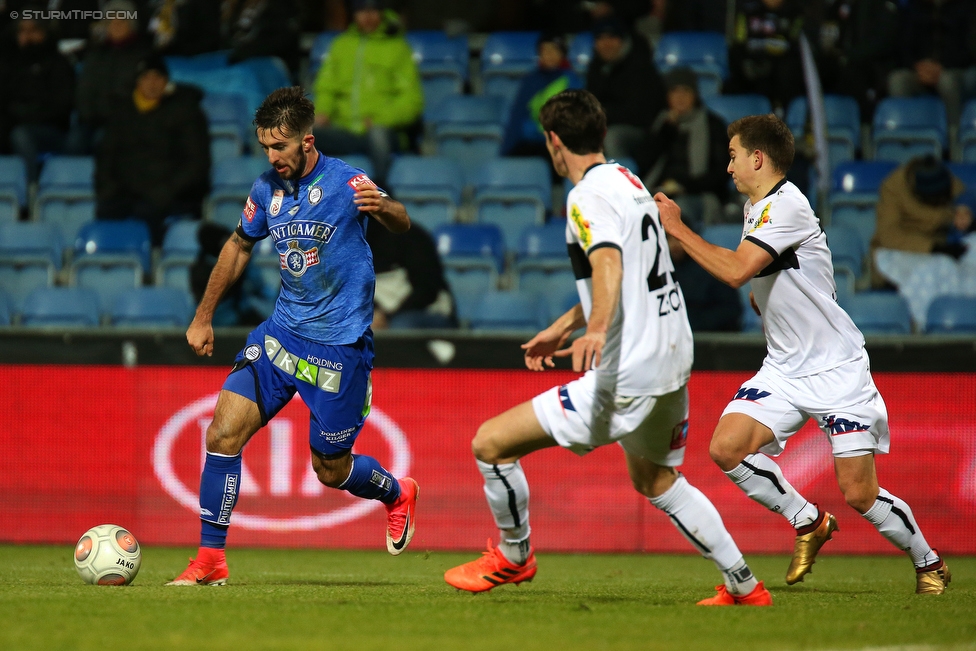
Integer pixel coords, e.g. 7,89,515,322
888,0,976,125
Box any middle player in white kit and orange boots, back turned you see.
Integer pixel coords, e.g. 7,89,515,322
444,90,772,606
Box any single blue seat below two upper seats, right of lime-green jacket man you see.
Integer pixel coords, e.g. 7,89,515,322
431,95,505,171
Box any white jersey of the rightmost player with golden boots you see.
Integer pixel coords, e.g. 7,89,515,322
742,180,864,377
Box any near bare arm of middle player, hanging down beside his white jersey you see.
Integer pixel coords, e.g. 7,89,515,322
554,247,623,372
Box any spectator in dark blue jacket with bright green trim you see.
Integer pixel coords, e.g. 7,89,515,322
502,33,583,156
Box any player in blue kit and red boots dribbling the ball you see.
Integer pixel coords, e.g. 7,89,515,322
167,86,419,585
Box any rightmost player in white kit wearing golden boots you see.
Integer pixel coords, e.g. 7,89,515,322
654,115,951,594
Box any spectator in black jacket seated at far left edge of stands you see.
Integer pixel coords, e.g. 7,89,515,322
0,13,74,182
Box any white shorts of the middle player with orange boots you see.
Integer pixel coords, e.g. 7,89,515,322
532,371,688,467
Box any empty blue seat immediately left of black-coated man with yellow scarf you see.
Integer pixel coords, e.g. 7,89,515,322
34,156,95,246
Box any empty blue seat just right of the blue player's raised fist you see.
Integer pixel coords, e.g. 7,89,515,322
386,156,464,230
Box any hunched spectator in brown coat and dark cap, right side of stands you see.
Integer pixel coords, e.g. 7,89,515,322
871,155,968,288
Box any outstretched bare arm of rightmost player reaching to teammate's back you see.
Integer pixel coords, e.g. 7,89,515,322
654,192,773,289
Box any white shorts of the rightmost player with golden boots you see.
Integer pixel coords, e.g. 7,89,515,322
722,351,890,457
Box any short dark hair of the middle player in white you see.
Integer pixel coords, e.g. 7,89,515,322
539,88,607,155
